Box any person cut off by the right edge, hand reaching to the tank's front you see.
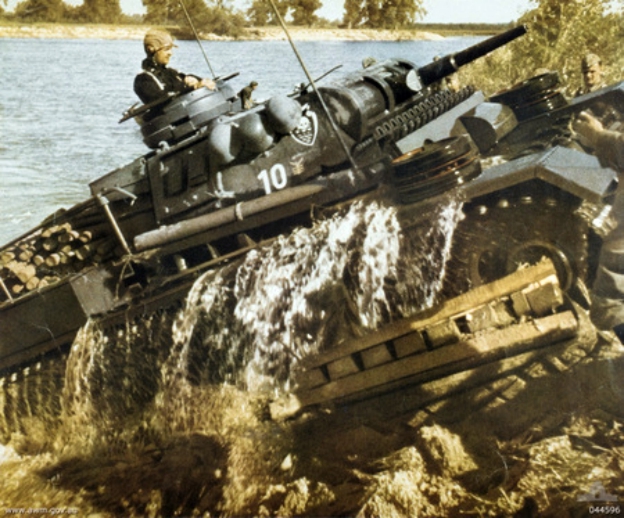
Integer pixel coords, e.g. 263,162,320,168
572,112,624,343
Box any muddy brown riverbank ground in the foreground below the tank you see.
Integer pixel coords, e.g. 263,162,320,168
0,306,624,518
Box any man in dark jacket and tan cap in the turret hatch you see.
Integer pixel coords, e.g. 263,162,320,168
134,29,216,104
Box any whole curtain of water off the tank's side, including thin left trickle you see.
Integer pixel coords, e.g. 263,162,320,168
3,196,461,440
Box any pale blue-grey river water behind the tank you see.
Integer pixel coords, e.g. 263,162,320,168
0,37,480,243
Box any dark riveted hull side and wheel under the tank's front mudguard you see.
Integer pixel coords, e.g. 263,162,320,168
445,194,589,294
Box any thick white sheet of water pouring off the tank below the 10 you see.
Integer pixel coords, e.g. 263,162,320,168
163,198,460,398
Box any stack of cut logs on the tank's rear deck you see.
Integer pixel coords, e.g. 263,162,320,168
0,223,116,300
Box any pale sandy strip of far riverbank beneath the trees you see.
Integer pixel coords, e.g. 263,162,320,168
0,23,443,41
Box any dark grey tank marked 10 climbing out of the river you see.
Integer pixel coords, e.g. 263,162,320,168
0,26,624,398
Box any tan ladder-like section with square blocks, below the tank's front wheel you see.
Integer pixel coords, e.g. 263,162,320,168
271,261,578,419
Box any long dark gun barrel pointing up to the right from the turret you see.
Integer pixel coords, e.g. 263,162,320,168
418,25,527,86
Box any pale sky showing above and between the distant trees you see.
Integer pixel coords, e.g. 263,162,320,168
3,0,535,23
